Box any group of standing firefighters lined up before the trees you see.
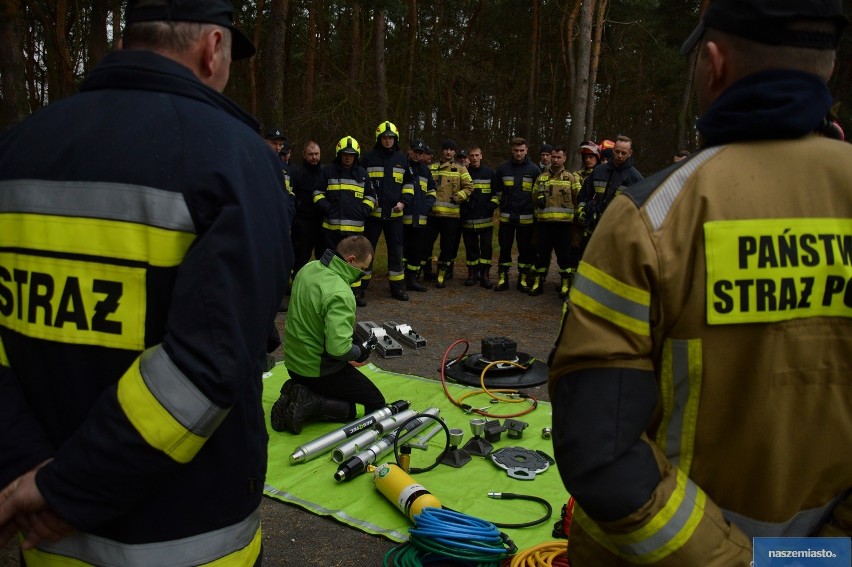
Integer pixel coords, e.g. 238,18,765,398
274,121,642,306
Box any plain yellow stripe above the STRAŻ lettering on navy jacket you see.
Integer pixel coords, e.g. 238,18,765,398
0,213,195,268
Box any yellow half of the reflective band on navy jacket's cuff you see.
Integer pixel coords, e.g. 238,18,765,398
118,357,207,463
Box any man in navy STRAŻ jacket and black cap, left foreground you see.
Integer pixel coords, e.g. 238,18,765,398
0,0,292,566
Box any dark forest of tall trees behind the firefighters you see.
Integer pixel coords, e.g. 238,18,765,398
0,0,852,175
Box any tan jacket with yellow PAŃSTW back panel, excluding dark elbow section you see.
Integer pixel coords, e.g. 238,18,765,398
550,135,852,566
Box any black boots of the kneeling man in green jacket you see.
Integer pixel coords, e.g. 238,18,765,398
270,380,353,435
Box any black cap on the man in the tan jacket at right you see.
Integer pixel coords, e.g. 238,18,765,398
680,0,848,55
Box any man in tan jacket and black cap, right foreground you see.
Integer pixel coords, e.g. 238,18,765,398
549,0,852,567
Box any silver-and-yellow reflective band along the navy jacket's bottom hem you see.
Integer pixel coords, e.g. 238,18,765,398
24,509,261,567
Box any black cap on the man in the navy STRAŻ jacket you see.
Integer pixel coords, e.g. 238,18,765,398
127,0,255,60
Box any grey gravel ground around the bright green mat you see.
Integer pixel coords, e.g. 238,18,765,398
0,266,562,567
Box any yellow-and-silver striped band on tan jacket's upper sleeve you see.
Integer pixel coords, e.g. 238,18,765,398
571,262,651,337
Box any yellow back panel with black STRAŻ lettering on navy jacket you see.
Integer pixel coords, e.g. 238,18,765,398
0,252,147,350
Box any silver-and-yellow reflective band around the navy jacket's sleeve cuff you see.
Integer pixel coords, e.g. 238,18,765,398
118,346,228,463
